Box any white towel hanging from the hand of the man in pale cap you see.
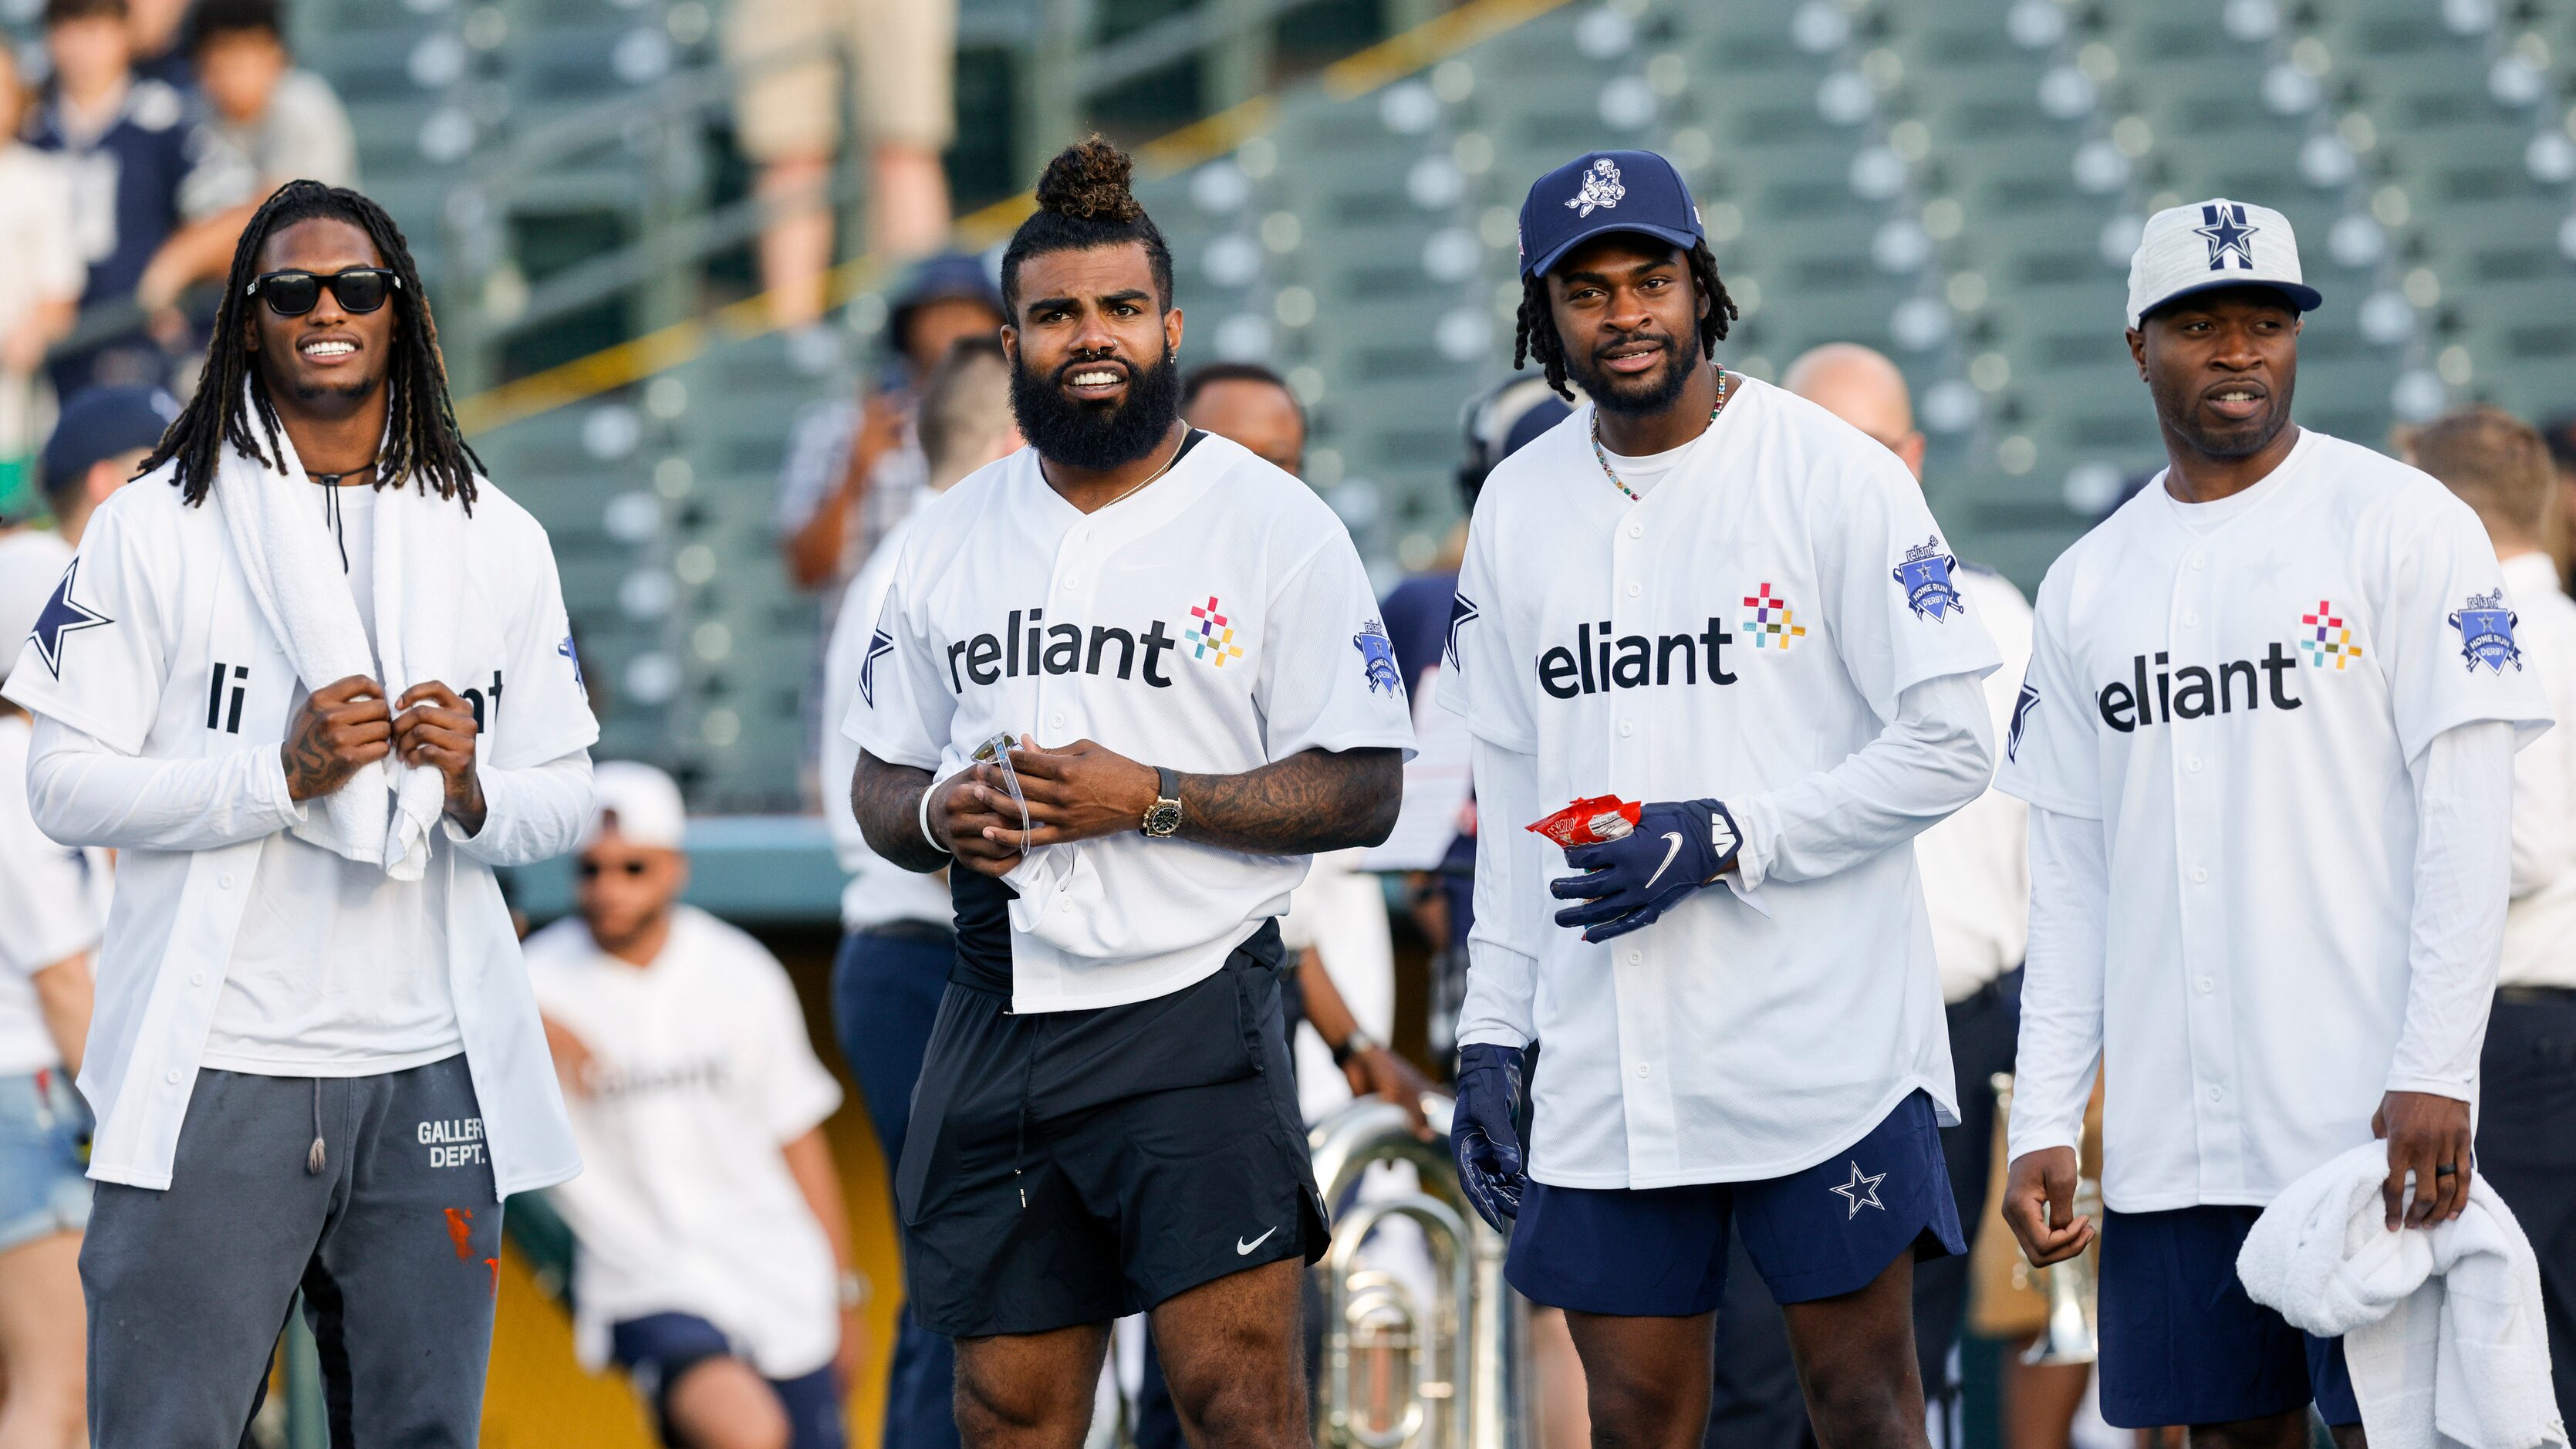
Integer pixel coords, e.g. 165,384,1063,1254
2236,1142,2568,1449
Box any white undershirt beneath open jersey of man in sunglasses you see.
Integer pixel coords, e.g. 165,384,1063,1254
204,488,464,1078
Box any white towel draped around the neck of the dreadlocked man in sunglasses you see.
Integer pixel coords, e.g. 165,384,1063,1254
214,383,466,882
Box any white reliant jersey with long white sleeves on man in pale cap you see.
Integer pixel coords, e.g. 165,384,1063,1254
1999,431,2551,1212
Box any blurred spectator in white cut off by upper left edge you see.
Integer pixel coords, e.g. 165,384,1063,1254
0,44,85,521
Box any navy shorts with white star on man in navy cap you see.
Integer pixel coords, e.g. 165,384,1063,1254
1504,1091,1968,1318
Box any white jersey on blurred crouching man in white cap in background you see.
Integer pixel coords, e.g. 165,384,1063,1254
528,905,840,1380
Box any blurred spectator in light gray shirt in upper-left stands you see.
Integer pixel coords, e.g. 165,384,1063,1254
137,0,358,309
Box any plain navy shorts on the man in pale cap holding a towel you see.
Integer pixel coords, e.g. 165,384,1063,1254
2102,1207,2362,1428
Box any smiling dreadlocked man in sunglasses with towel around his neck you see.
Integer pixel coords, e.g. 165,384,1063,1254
8,183,598,1444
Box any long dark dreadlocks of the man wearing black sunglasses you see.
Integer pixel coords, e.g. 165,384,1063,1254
142,181,484,513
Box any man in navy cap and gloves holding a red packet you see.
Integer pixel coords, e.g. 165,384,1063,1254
1437,152,1997,1447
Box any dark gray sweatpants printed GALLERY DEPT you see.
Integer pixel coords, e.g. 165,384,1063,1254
80,1057,500,1449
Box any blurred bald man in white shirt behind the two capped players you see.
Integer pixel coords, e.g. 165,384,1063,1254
1770,343,2030,1424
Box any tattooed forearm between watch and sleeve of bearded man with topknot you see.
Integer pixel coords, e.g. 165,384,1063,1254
1180,750,1404,856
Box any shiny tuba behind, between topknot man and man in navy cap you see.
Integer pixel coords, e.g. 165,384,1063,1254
1306,1096,1525,1449
